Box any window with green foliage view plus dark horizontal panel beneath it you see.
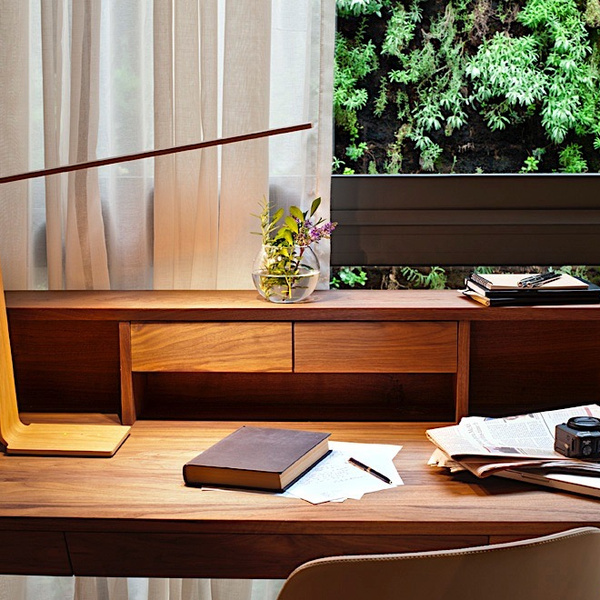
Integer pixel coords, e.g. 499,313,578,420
332,0,600,266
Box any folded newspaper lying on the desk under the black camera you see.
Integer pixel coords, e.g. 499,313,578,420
427,404,600,477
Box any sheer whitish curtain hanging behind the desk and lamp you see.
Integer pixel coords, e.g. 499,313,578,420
0,0,335,600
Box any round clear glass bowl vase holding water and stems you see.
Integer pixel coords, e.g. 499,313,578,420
252,246,320,304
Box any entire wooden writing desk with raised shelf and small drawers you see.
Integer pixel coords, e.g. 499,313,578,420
0,291,600,577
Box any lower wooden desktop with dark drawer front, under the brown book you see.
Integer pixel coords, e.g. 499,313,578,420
0,421,600,577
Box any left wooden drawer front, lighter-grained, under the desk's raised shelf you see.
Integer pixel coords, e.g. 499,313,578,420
131,322,292,373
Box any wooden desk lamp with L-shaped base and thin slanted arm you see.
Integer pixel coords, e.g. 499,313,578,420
0,123,312,456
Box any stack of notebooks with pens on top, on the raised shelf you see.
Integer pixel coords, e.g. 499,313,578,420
462,273,600,306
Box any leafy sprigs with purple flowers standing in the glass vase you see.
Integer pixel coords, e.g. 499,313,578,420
255,198,337,300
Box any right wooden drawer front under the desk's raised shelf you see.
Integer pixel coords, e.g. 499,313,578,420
294,321,458,373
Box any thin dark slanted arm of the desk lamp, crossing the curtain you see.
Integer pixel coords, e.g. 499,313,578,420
0,123,312,184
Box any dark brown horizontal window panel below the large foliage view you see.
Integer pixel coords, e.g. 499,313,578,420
331,173,600,266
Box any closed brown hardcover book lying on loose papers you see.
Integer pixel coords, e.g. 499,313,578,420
183,426,330,492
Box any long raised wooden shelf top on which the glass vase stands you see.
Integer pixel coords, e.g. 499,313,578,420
6,290,600,321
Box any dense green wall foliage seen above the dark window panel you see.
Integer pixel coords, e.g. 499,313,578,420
334,0,600,173
